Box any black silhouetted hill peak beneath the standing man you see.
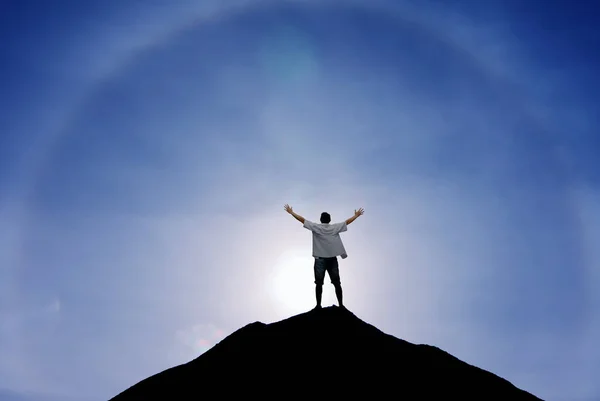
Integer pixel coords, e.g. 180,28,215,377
110,306,540,401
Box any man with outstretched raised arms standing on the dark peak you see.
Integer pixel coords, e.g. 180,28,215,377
284,205,365,309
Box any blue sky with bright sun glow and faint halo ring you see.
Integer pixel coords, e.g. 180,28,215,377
0,0,600,401
